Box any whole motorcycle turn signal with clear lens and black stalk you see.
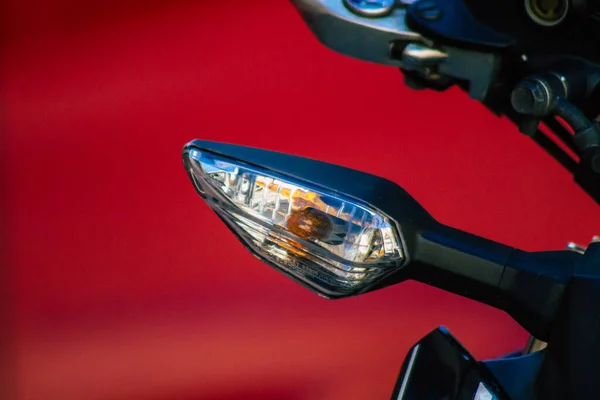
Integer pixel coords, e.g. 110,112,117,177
183,140,580,339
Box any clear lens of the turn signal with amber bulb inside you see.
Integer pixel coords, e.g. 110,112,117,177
188,149,404,295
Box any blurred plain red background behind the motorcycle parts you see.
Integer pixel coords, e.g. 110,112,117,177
0,0,600,400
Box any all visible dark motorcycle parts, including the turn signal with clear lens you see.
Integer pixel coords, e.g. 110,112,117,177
183,0,600,400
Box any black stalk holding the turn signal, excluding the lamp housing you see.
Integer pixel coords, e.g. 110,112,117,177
408,225,581,341
